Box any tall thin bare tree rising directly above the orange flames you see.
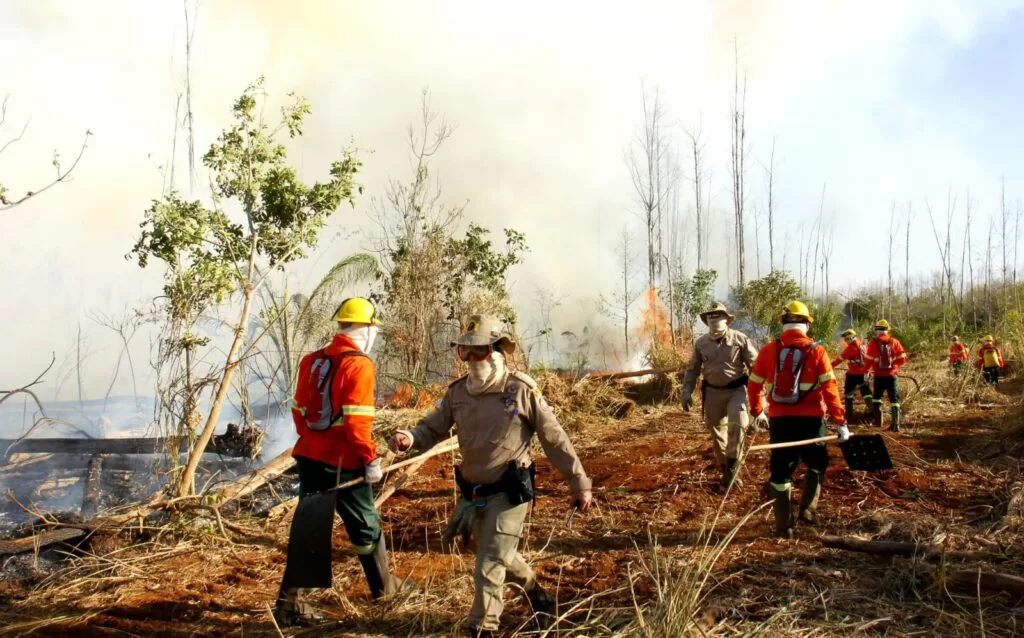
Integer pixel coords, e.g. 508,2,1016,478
626,85,668,288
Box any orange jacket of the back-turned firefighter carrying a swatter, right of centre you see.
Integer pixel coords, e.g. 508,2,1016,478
746,330,846,423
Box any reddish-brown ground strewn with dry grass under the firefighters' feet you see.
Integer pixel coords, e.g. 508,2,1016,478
0,376,1024,636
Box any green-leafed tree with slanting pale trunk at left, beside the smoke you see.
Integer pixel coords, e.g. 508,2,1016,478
129,78,360,496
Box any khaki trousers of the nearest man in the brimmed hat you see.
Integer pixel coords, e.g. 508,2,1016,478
469,494,537,631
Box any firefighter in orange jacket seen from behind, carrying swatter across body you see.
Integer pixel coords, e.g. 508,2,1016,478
746,301,850,539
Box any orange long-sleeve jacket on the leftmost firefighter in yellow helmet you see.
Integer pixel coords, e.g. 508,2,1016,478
292,335,377,470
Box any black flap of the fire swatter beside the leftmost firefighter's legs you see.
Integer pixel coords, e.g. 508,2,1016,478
282,492,338,588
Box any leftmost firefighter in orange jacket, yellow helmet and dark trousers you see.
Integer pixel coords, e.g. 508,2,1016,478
274,297,396,625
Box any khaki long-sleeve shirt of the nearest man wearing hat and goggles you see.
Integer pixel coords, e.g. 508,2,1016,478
409,372,591,492
